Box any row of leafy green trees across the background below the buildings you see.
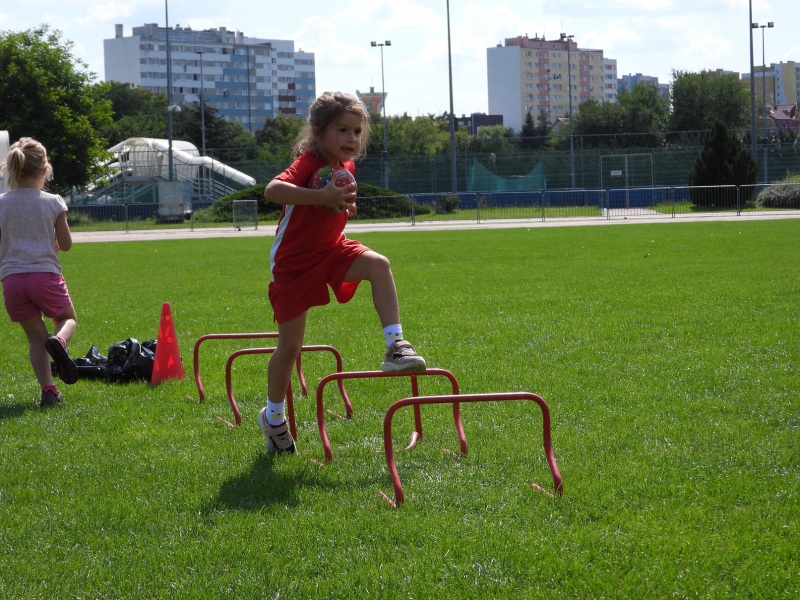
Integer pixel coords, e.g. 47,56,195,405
0,25,788,189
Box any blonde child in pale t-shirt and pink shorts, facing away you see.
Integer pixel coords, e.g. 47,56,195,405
0,137,78,407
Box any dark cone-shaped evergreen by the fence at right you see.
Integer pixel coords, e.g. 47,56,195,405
689,120,758,208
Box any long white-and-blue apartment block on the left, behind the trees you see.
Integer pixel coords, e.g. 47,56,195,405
103,23,316,132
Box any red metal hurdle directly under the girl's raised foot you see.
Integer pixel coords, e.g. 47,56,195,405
317,369,460,462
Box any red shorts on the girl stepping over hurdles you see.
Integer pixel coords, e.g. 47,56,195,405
269,239,369,323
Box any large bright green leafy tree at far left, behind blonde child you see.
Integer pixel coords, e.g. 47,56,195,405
0,25,111,189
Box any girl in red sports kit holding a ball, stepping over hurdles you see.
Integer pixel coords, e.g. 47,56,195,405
258,92,425,453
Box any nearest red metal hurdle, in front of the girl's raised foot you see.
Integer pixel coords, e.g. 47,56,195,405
383,392,564,505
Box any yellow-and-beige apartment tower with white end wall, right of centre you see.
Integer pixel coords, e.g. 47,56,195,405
486,34,617,131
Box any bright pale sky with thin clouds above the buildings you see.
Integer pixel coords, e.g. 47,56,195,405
0,0,800,117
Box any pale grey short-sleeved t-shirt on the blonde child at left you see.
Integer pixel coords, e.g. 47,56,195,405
0,188,67,281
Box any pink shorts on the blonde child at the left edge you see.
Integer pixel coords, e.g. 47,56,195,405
3,273,72,323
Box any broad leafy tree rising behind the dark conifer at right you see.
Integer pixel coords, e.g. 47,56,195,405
670,71,750,131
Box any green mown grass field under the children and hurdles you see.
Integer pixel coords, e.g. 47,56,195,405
0,220,800,599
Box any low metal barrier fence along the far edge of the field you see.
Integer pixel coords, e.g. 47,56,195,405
69,184,800,232
